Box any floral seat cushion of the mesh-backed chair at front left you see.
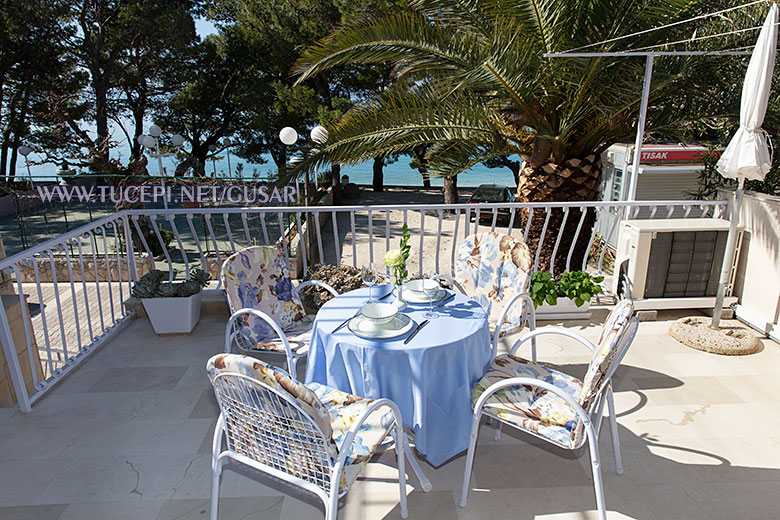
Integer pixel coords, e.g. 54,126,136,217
308,383,393,489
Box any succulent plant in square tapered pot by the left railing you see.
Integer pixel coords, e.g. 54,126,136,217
133,269,209,334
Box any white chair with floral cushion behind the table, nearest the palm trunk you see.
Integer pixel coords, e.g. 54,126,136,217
436,232,536,360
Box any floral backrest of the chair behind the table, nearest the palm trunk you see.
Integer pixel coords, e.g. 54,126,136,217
455,232,531,324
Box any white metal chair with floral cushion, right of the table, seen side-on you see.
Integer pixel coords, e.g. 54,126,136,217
460,300,639,519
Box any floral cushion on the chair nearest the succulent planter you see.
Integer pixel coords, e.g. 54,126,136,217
221,245,306,342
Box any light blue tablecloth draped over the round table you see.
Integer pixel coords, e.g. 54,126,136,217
306,285,490,466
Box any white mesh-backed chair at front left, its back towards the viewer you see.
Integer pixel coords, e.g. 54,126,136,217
207,354,416,520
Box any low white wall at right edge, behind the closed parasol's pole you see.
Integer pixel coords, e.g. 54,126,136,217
719,189,780,340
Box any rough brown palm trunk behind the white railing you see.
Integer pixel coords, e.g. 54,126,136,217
517,155,601,275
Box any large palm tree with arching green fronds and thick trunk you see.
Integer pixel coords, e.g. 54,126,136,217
294,0,736,272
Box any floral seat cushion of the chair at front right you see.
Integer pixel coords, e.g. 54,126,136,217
471,354,582,449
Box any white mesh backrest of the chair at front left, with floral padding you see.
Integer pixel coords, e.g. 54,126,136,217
206,354,338,491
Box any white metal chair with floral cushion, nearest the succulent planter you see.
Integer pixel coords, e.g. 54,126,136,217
221,245,338,378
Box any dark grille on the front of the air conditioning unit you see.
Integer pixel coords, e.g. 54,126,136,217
644,231,728,298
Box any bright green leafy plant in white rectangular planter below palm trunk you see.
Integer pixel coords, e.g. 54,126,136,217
529,271,604,320
